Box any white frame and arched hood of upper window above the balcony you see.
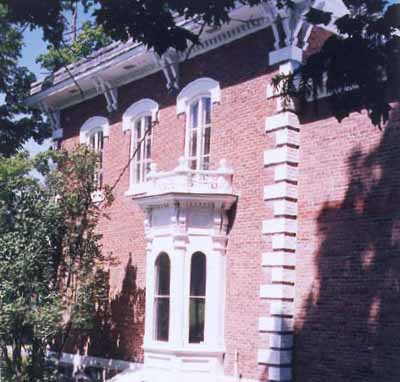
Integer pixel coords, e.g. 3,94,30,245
176,77,221,169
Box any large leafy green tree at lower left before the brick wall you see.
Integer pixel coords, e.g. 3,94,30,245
0,146,112,381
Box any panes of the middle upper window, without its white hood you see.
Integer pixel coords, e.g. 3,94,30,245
131,115,152,184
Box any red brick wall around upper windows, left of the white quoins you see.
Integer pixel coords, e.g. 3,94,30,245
62,27,274,378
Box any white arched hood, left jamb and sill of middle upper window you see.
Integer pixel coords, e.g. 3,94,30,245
122,98,159,196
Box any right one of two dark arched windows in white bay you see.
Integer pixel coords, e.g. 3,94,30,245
189,252,206,343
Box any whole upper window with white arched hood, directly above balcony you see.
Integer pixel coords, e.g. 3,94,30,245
177,78,221,170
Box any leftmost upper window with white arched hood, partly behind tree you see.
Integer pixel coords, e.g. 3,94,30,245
79,117,110,188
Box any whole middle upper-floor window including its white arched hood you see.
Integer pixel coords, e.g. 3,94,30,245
122,98,158,192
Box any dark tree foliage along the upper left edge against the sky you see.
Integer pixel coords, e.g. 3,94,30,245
0,1,50,156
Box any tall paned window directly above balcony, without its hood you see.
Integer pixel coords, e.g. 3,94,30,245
187,97,211,170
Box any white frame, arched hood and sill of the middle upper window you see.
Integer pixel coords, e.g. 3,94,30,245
122,98,159,195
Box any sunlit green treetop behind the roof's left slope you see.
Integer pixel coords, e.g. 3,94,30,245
36,22,112,72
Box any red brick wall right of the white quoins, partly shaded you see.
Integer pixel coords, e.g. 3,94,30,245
294,106,400,382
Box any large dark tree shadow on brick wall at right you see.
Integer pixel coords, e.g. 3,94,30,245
294,106,400,382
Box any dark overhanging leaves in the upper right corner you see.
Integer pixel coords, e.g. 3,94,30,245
275,0,400,127
